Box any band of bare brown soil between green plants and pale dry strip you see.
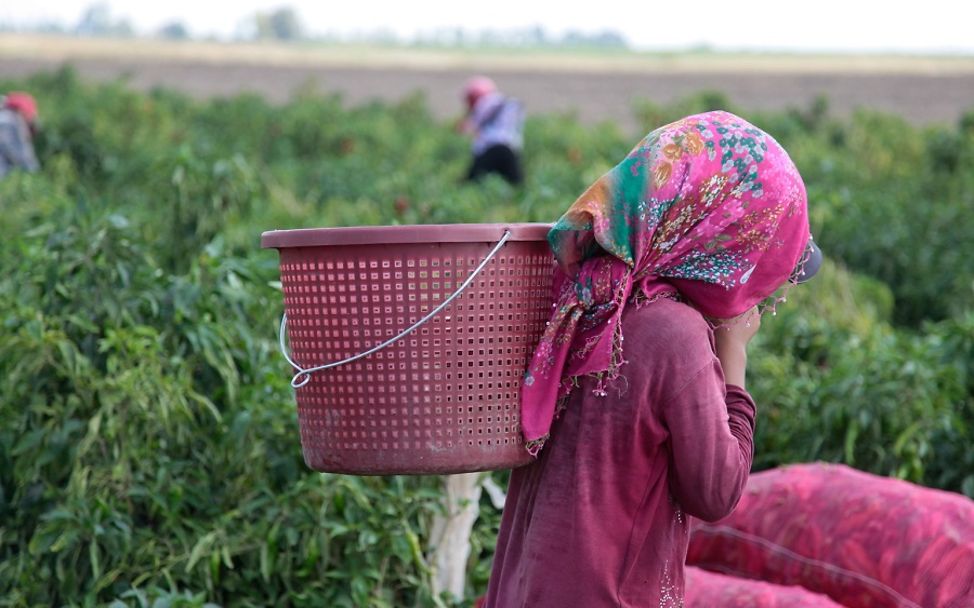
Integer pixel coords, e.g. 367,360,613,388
0,56,974,130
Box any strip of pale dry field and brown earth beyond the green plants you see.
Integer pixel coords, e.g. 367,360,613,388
0,35,974,131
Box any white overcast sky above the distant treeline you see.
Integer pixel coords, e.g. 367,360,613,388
0,0,974,53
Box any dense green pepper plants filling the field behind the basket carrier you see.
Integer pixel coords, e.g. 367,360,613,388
0,70,974,607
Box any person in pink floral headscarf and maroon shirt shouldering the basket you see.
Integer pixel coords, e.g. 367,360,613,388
485,112,821,608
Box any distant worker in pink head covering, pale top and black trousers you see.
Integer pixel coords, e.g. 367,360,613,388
458,76,524,185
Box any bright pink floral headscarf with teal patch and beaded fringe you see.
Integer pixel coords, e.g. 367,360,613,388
521,112,809,454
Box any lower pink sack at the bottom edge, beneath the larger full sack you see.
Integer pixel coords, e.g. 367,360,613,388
684,566,841,608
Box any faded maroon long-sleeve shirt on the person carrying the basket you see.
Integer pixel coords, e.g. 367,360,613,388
485,299,755,608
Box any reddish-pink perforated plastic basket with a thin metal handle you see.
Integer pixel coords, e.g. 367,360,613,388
261,224,554,475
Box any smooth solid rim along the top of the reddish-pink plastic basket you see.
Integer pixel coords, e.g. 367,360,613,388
260,223,551,249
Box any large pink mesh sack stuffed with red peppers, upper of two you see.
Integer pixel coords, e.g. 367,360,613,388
687,464,974,608
